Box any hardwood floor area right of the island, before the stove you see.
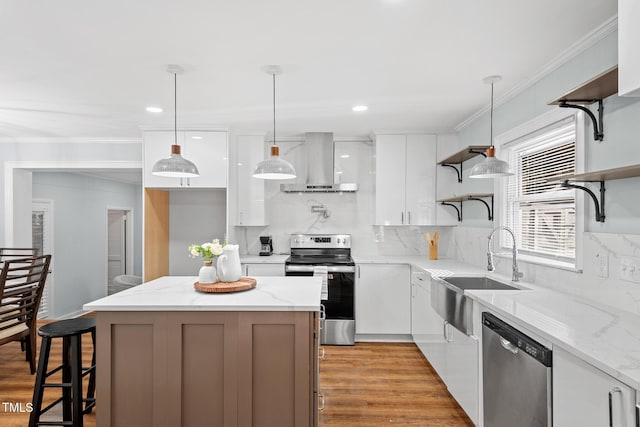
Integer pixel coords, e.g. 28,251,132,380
320,343,473,427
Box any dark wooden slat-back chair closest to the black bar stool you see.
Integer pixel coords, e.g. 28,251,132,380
0,255,51,374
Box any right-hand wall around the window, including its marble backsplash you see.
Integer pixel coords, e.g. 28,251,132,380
438,33,640,313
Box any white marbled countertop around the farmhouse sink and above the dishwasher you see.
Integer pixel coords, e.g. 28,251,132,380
354,256,640,390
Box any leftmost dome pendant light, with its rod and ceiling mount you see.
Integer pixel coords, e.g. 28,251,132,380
151,64,200,178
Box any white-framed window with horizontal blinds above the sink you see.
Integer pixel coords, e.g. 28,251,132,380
502,117,576,264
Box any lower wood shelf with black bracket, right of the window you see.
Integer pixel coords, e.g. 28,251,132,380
547,164,640,222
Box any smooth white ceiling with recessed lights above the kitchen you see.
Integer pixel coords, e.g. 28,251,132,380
0,0,617,138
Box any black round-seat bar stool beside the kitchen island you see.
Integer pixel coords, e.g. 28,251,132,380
29,317,96,427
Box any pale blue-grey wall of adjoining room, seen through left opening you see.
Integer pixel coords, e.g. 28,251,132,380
32,172,142,318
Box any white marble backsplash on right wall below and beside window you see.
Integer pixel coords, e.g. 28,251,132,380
446,227,640,314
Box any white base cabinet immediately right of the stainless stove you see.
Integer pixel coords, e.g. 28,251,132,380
355,264,411,335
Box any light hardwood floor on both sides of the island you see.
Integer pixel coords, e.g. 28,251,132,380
0,324,473,427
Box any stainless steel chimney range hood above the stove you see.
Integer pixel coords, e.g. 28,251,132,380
280,132,358,193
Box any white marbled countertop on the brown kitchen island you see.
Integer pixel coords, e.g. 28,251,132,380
83,276,322,311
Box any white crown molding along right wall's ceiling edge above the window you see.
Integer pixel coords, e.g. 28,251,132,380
454,15,618,132
